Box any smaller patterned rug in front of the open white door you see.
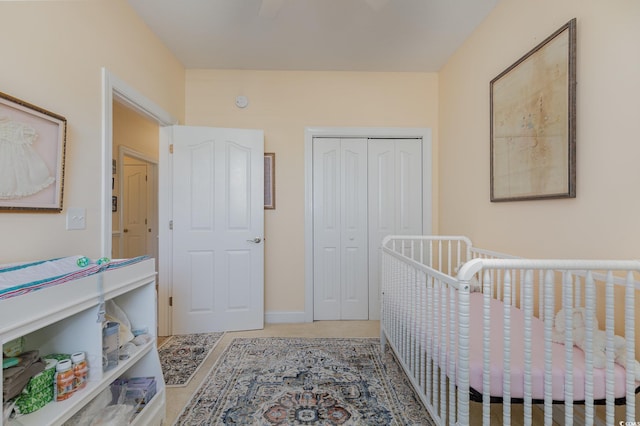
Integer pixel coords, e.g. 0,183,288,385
158,333,224,387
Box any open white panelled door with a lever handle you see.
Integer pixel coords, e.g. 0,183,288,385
172,126,264,334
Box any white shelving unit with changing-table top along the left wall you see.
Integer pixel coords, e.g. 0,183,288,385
0,259,166,426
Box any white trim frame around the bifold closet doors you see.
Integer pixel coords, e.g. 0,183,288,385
304,127,433,322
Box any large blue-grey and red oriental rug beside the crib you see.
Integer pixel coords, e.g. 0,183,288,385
174,338,433,426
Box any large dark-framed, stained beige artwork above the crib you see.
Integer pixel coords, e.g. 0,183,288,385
490,19,576,201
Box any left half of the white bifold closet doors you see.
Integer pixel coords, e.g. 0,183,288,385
313,138,369,320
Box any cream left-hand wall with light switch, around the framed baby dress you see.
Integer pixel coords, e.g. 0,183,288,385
0,0,184,262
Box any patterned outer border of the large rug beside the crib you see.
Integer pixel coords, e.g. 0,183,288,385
173,336,435,426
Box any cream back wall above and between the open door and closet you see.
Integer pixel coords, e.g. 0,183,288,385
186,70,438,312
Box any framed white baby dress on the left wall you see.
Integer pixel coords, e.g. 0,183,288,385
0,93,67,212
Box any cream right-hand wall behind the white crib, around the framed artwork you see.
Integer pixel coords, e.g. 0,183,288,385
439,0,640,259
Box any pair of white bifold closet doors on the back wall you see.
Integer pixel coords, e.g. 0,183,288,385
313,138,422,320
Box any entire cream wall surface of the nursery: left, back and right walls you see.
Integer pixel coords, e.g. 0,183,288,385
6,0,640,318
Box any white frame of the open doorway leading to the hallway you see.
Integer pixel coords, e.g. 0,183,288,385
100,68,178,336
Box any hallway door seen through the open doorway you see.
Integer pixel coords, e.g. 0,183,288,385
121,161,150,258
